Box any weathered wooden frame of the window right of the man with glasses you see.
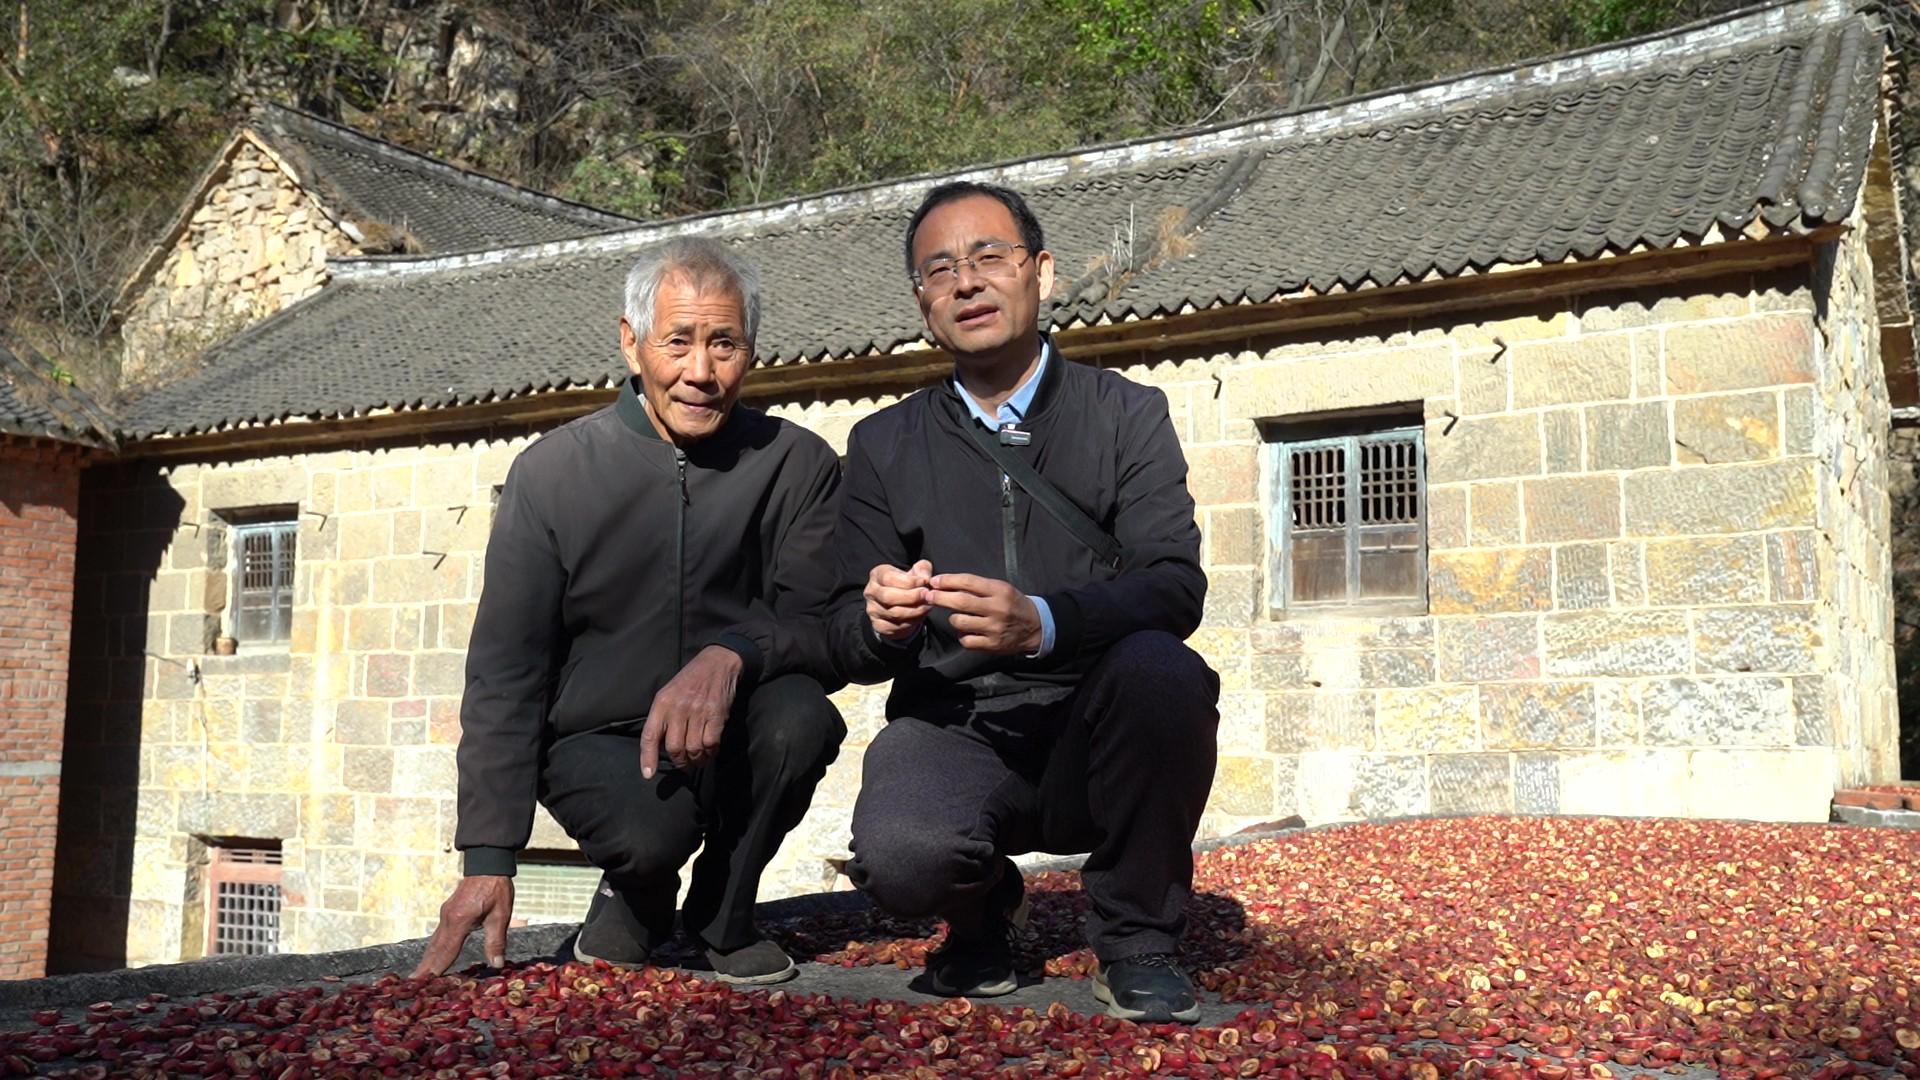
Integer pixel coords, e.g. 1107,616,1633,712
1263,413,1428,619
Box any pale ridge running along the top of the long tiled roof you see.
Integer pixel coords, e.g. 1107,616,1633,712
330,0,1857,281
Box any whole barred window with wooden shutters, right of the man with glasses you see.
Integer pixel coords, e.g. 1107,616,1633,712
1269,427,1427,611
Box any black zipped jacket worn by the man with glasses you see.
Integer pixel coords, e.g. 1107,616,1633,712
829,330,1206,719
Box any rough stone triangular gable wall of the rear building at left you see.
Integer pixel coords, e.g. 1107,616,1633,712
121,133,357,386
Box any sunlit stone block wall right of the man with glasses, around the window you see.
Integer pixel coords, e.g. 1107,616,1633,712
1167,271,1891,832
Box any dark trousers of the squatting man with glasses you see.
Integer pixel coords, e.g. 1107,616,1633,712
847,632,1219,963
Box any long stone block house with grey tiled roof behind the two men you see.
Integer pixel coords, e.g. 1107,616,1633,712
54,0,1905,969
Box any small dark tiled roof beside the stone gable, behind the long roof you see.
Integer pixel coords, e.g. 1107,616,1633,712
253,106,634,254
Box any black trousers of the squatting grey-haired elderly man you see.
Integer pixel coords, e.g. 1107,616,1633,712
541,675,847,951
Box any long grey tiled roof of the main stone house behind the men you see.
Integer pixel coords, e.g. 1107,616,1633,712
129,0,1884,438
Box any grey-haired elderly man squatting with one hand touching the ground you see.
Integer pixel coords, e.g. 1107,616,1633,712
415,238,847,984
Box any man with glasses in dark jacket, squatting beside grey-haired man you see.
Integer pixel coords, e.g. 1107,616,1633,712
829,183,1219,1022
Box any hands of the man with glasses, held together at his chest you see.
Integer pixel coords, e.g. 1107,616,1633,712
864,559,1041,655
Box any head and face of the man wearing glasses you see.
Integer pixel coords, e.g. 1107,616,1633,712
914,194,1054,359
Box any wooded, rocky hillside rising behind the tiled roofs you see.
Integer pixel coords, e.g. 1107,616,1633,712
0,0,1781,357
